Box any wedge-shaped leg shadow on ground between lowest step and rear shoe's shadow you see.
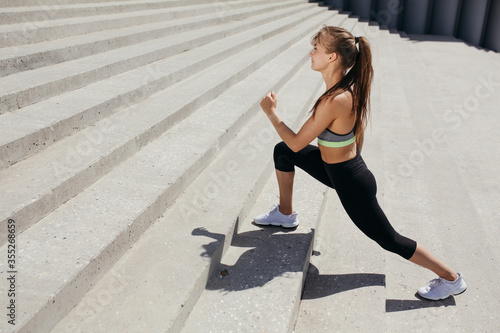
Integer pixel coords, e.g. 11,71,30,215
302,264,385,299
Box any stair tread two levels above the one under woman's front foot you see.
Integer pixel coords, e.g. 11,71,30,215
0,13,330,330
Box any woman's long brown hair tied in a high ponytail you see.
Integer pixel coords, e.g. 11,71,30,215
311,26,373,151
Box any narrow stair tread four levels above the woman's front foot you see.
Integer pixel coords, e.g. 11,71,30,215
0,1,320,150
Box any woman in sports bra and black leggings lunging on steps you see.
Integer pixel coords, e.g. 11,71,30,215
254,26,466,300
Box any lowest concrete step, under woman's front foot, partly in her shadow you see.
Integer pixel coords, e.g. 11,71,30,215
183,15,367,332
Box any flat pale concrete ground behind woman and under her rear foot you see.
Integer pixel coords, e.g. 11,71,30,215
295,20,500,332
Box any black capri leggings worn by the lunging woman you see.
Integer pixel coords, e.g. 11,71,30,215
274,142,417,259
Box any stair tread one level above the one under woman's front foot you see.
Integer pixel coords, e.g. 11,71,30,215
53,50,320,332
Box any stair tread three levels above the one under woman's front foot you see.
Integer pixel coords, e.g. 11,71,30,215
0,4,332,246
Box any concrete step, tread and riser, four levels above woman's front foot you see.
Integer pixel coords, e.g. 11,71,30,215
0,1,318,167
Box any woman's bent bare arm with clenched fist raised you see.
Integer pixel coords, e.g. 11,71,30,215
260,92,346,152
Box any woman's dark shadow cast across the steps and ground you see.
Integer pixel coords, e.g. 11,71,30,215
192,226,455,312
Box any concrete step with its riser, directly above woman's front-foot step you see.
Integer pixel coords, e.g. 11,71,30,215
49,53,324,333
